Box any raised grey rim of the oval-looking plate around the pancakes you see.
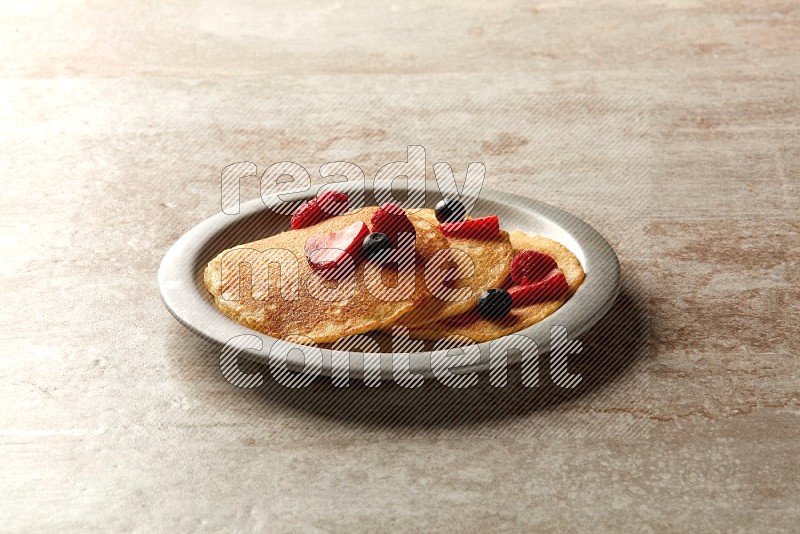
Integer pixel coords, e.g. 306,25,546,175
158,180,620,379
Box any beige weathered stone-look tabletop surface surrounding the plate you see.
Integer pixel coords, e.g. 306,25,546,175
0,0,800,532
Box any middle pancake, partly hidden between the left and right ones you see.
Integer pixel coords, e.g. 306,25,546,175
399,209,514,328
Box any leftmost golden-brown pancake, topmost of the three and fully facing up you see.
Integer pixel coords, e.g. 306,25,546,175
204,207,447,344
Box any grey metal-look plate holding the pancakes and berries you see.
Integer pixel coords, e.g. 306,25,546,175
158,181,619,384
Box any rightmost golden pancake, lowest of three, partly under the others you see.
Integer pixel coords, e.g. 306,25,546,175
411,231,585,343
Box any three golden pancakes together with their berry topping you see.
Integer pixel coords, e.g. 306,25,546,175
204,191,585,344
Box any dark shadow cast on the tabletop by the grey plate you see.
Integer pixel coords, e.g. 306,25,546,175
167,282,650,429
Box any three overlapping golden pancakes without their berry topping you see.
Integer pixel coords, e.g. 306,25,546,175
204,199,584,344
